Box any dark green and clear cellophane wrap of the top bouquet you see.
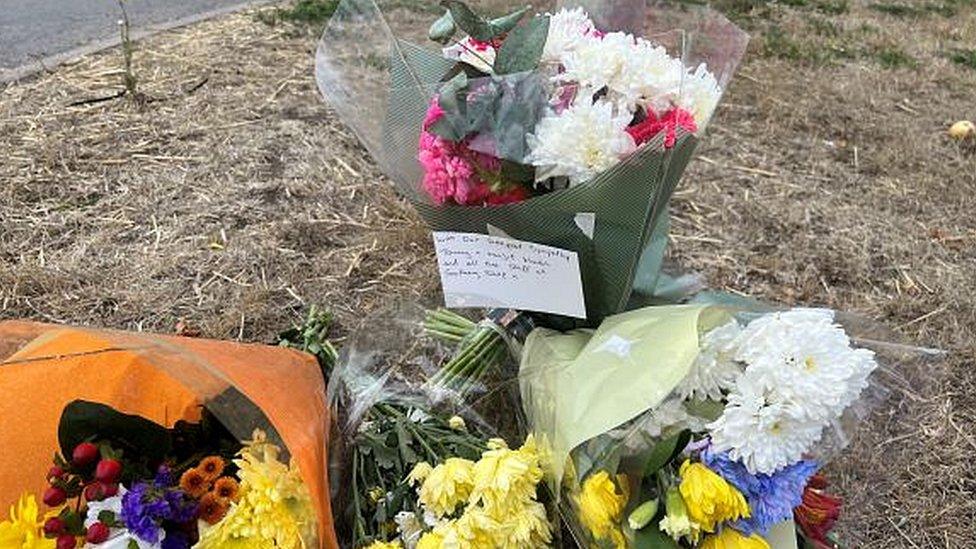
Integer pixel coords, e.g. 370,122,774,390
316,0,748,324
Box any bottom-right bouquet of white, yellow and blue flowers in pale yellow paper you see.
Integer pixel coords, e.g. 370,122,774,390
519,305,932,549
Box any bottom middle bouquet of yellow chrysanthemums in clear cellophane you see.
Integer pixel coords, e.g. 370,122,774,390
330,307,552,549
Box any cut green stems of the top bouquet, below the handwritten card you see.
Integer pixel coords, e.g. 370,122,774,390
424,309,508,396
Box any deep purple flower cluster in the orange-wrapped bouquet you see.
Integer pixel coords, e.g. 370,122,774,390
120,482,196,547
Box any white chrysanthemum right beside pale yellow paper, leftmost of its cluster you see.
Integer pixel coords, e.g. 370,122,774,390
675,320,743,400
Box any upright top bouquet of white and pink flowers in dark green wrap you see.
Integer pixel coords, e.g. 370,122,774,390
316,0,746,322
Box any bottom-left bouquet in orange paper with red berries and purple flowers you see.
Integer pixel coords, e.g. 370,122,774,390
0,322,337,549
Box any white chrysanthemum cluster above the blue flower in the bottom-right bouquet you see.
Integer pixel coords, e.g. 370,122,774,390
696,309,877,473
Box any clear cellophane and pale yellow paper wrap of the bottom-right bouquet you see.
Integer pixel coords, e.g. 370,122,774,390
519,299,942,549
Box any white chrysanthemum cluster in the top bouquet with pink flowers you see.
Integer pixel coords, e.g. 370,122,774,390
526,8,722,184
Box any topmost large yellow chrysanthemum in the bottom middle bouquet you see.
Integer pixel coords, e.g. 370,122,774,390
471,435,543,517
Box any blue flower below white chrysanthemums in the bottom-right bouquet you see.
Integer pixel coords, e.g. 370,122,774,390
702,450,820,536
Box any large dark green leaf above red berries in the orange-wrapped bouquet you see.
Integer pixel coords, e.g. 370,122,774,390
58,400,172,461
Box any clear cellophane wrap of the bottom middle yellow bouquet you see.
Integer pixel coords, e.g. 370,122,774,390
328,302,526,542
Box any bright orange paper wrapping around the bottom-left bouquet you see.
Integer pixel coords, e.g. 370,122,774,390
0,321,338,548
